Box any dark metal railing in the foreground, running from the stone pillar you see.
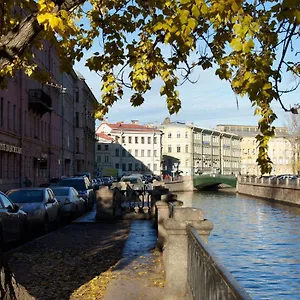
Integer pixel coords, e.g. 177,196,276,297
187,225,251,300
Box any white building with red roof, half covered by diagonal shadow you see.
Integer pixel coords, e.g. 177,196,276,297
95,120,162,176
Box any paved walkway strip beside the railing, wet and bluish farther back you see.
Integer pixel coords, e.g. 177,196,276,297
104,220,165,300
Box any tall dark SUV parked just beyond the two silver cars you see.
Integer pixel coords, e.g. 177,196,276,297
57,176,95,210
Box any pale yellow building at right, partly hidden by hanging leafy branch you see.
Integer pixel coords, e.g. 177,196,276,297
217,125,295,176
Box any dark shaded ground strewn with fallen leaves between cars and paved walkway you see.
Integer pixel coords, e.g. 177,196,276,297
4,221,130,300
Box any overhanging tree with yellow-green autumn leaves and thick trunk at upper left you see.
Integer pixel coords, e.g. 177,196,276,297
0,0,300,173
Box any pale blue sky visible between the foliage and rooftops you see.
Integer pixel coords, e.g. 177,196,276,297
74,3,300,128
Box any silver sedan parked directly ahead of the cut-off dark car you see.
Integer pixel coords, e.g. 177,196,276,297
7,188,60,233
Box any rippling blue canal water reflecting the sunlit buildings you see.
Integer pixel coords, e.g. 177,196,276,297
177,191,300,300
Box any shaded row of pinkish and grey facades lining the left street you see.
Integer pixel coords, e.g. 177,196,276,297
0,43,96,191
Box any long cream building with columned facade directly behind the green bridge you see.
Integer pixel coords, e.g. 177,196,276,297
156,118,241,175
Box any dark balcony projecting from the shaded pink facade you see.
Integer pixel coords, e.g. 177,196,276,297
28,89,52,116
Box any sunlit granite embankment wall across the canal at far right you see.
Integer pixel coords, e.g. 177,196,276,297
237,180,300,206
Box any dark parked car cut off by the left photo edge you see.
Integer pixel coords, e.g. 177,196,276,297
0,192,27,247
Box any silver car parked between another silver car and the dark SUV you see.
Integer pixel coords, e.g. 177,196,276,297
52,186,85,218
